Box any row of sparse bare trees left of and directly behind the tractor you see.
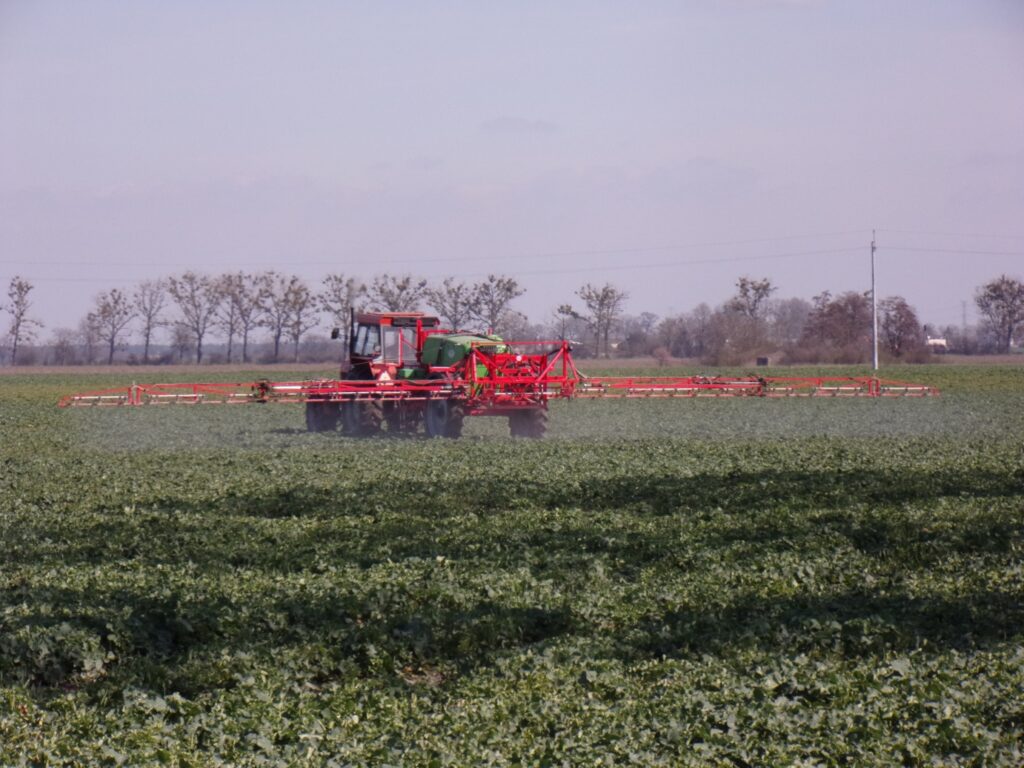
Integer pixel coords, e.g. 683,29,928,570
2,270,530,365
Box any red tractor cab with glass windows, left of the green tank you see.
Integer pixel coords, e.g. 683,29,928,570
332,312,440,379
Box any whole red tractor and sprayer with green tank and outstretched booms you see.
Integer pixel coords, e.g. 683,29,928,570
60,312,938,437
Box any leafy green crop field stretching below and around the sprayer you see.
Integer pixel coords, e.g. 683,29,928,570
0,366,1024,766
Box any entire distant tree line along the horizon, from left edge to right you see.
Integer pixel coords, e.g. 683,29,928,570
0,270,1024,365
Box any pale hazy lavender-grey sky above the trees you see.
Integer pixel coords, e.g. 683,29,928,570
0,0,1024,329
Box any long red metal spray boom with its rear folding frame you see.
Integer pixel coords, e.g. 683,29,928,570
59,342,939,416
